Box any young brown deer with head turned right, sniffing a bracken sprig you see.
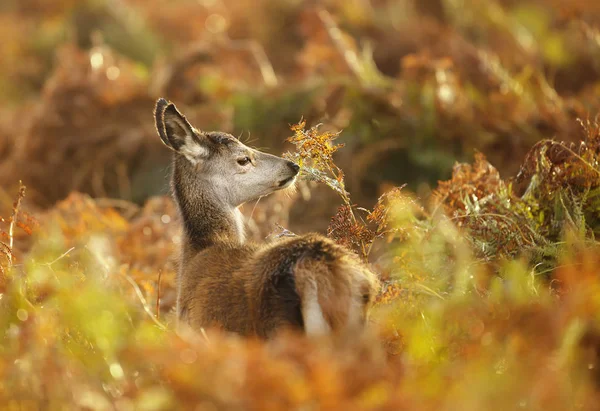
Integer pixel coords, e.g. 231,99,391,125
155,99,378,338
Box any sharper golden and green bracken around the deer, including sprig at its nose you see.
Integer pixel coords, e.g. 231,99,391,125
0,118,600,409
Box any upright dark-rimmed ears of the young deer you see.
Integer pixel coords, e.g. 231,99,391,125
154,98,209,164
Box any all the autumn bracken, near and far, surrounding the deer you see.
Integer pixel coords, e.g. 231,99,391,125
0,0,600,410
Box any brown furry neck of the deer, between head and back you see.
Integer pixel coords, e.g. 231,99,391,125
173,161,245,252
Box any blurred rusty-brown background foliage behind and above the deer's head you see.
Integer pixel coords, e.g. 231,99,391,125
0,0,600,214
